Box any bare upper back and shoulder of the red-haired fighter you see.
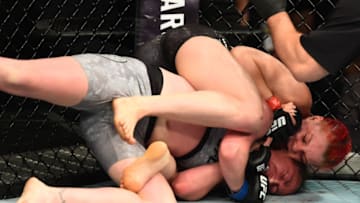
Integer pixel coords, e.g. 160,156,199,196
231,46,312,116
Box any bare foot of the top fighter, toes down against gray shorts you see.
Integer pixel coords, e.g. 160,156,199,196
112,97,144,144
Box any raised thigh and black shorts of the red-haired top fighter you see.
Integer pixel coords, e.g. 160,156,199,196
160,25,261,104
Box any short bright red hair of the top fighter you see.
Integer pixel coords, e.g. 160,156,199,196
323,118,352,168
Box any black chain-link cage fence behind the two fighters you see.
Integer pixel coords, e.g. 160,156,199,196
0,0,360,198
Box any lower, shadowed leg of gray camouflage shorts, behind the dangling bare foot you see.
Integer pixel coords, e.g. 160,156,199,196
80,104,148,174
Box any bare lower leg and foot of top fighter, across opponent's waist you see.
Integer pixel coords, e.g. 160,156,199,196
113,91,264,140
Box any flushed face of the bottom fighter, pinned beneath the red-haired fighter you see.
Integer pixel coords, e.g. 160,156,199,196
266,150,302,195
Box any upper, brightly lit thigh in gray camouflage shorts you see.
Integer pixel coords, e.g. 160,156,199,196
73,54,151,110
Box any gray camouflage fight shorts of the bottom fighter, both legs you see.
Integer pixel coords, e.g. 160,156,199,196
73,54,151,171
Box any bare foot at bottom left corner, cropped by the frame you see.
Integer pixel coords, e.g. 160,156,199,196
16,177,61,203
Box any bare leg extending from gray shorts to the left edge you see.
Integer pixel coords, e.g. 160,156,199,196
0,56,88,106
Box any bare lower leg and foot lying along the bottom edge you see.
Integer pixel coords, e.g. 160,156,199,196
17,173,176,203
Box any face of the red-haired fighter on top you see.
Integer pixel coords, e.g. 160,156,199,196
287,116,328,167
